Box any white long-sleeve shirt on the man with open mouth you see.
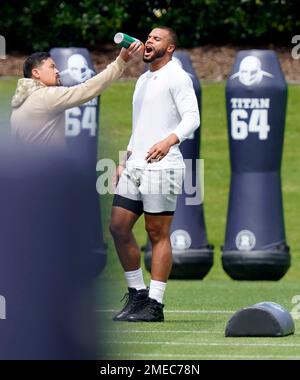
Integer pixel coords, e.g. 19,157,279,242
127,60,200,169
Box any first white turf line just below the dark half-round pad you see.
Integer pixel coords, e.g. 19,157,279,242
109,341,300,347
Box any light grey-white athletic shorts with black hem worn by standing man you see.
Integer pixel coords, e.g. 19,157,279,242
113,167,185,215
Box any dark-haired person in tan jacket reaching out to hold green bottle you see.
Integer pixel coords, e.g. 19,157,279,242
10,43,142,147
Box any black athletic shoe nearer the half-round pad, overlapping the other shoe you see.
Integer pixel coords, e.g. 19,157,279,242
127,297,165,322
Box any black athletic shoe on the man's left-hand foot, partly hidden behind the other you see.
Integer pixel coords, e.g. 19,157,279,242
113,288,149,321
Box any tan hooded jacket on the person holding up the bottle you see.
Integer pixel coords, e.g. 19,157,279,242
10,57,127,146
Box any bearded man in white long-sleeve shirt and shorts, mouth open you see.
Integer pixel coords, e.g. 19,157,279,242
110,27,200,322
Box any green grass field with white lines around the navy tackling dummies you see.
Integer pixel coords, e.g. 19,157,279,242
0,78,300,359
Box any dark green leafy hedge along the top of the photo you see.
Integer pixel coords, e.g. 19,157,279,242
0,0,300,53
